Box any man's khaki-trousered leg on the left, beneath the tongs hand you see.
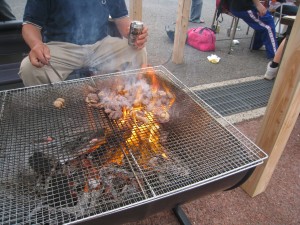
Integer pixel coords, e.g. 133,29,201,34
19,42,84,86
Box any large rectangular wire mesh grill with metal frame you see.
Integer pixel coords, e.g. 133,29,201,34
0,66,267,224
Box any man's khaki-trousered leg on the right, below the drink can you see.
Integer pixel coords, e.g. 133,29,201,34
86,36,147,73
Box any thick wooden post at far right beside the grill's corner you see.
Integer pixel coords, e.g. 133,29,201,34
242,10,300,197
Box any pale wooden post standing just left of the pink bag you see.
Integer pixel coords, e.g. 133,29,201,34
172,0,191,64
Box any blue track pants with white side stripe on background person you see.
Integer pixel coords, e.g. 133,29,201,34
231,7,278,59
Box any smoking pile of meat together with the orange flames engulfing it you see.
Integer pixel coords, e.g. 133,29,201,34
86,69,175,168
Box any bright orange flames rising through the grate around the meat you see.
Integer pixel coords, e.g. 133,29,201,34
85,69,175,179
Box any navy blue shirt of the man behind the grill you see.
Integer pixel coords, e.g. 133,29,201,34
23,0,128,45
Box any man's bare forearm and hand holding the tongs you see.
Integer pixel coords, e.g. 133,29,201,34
22,24,51,67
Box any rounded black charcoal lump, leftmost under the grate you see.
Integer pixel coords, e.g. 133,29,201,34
29,152,54,177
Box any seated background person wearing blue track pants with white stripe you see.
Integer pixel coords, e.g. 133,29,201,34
228,0,278,59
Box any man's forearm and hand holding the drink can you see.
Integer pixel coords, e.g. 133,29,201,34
114,16,148,49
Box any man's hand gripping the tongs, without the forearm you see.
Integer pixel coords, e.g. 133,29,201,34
29,43,51,68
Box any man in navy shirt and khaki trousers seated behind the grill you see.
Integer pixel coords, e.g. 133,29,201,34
19,0,148,86
